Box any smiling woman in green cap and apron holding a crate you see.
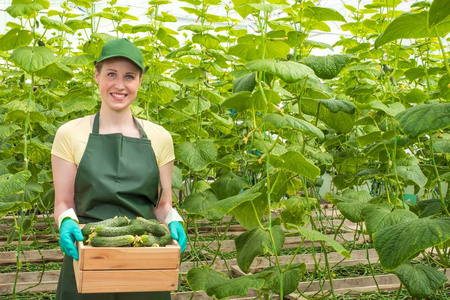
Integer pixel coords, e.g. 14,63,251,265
52,39,186,300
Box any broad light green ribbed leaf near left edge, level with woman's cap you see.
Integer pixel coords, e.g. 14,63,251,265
11,46,56,73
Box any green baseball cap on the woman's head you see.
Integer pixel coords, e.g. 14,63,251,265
95,38,145,72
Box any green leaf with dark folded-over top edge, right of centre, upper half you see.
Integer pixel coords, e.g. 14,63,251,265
301,98,356,133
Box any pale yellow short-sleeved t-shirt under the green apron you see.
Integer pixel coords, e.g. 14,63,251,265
52,116,175,167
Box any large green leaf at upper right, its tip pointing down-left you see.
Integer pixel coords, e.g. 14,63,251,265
375,11,450,47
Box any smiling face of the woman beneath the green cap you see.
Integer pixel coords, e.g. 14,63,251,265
95,57,142,111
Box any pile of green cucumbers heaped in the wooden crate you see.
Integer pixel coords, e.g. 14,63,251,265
81,217,172,247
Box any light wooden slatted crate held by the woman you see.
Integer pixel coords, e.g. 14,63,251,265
73,227,180,293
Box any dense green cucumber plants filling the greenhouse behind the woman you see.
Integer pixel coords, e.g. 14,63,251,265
0,0,450,298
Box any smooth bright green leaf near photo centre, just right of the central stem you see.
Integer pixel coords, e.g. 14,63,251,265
271,151,320,180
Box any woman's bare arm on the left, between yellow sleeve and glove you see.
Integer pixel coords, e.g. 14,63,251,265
52,155,77,222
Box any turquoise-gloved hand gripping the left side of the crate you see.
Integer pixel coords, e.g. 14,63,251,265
59,218,83,260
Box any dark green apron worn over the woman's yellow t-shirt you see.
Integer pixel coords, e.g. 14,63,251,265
56,114,171,300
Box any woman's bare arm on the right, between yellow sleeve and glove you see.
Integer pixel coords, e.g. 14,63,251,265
154,160,173,223
